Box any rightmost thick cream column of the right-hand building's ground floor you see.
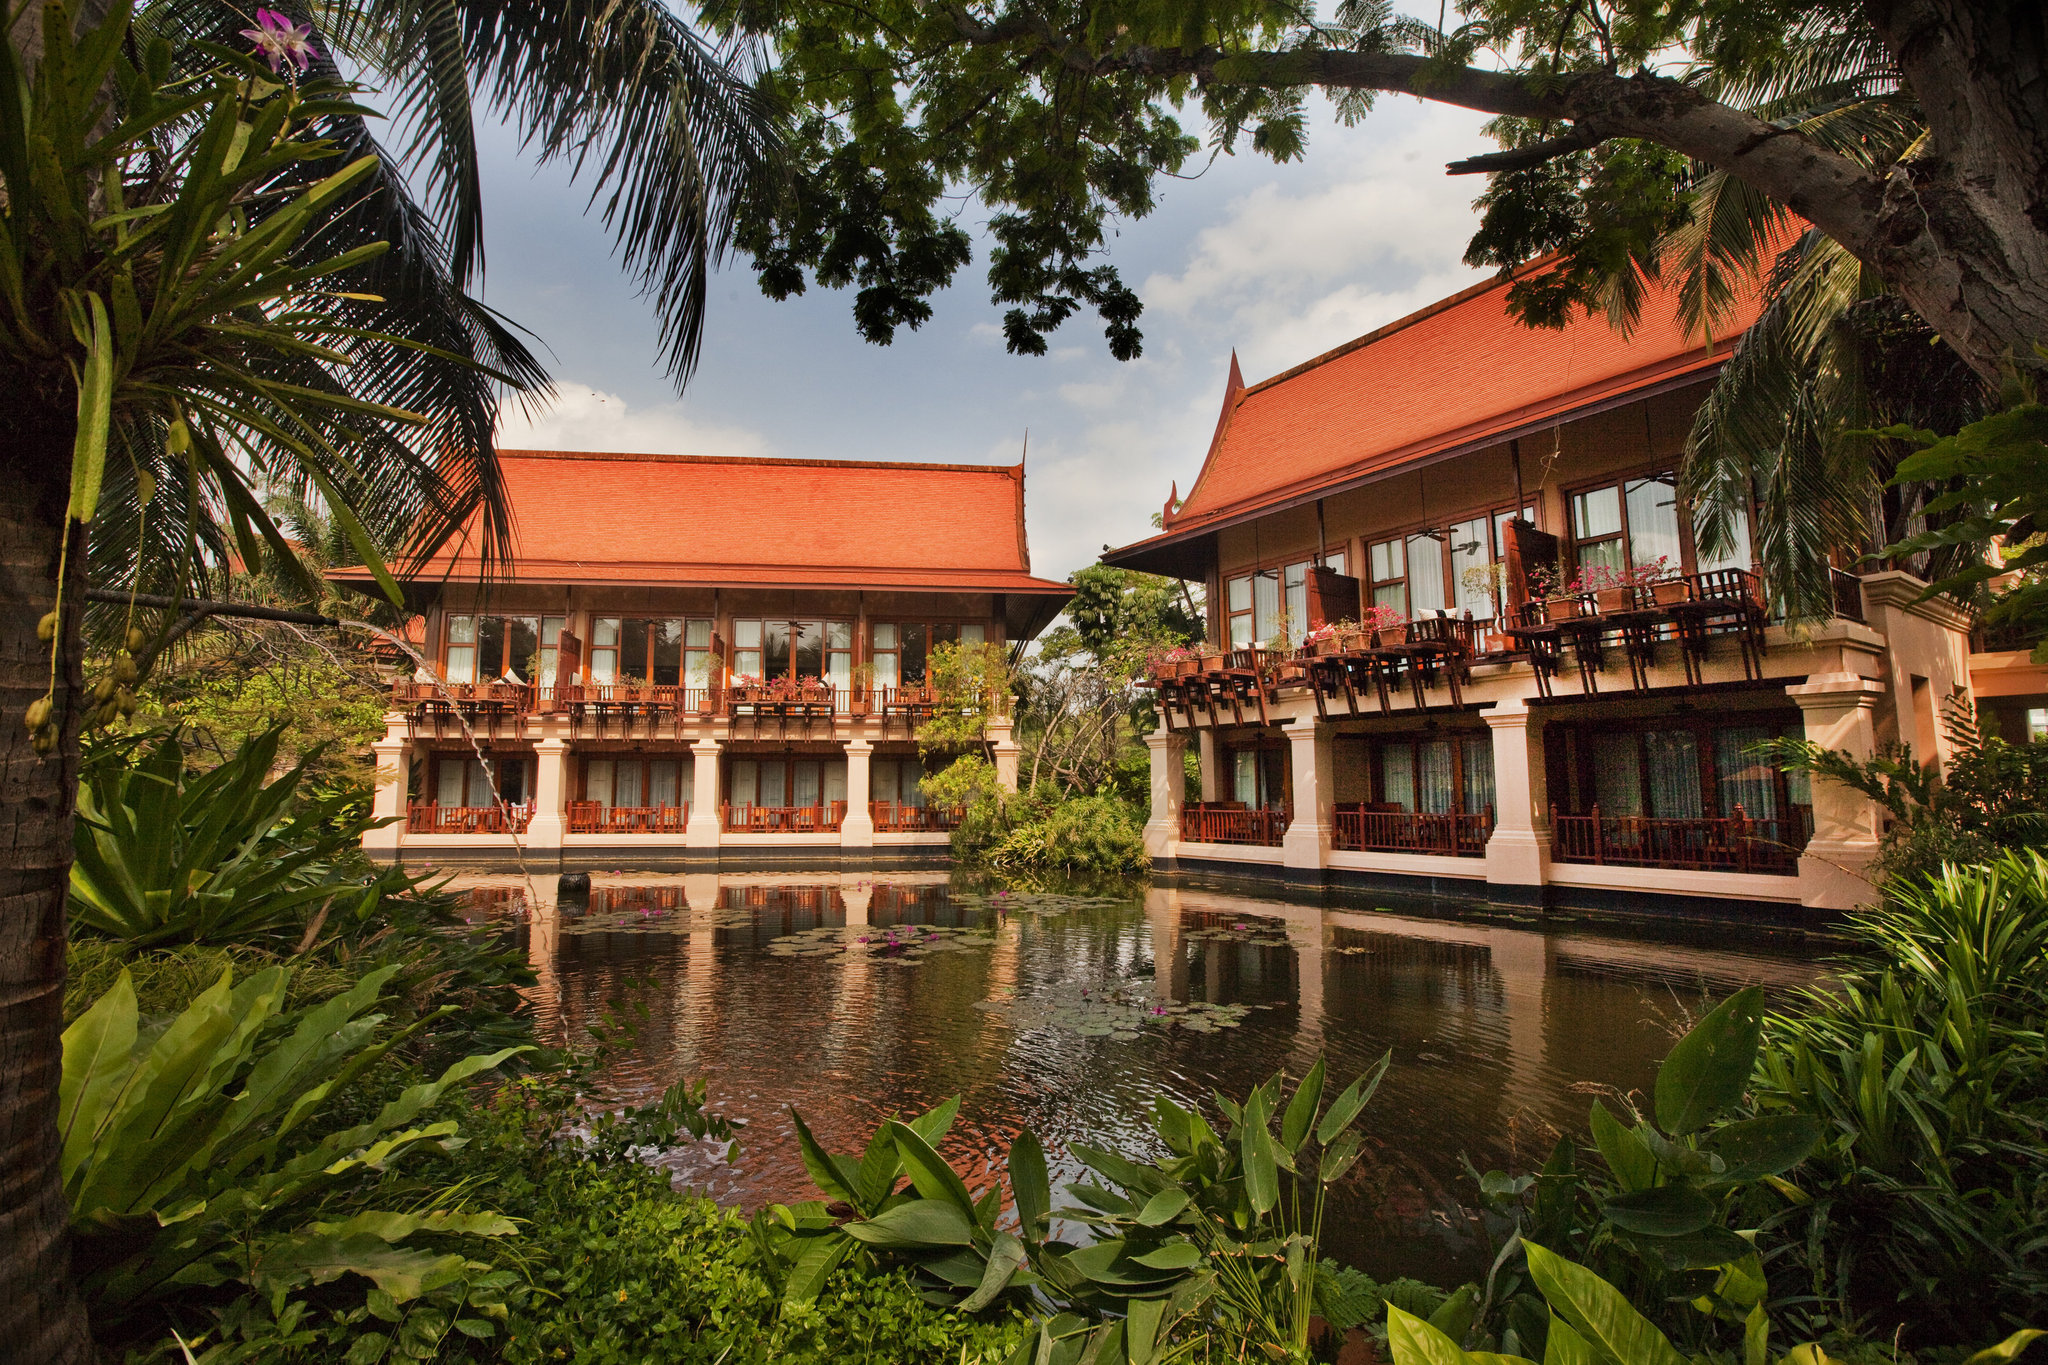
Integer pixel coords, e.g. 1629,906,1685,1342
1786,673,1884,911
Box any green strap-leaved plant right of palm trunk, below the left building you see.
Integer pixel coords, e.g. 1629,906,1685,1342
70,724,414,950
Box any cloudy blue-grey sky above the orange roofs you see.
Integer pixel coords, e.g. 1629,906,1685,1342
485,96,1489,577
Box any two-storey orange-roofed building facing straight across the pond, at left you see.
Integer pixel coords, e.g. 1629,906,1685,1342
332,450,1071,870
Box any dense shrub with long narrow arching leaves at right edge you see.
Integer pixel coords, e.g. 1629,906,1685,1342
1755,851,2048,1342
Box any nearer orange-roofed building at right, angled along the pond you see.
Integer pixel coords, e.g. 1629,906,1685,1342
1104,266,2048,911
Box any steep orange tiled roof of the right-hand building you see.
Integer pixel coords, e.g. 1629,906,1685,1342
1118,263,1755,555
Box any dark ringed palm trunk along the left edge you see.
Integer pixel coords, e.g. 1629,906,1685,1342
0,392,92,1365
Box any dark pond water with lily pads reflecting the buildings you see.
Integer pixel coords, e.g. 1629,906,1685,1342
479,874,1812,1279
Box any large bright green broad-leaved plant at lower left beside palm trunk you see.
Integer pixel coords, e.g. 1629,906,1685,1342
57,966,522,1332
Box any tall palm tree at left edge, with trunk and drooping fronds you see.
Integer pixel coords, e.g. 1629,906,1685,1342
0,0,772,1361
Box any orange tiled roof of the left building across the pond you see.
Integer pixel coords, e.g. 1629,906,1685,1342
334,450,1071,591
